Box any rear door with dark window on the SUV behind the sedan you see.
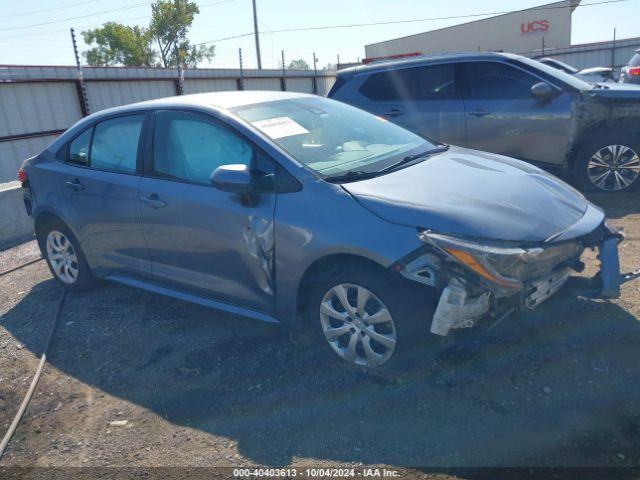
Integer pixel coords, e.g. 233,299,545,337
358,63,465,145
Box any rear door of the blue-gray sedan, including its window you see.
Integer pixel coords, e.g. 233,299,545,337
57,113,151,275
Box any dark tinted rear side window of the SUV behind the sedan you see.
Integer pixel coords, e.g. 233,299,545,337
360,64,456,101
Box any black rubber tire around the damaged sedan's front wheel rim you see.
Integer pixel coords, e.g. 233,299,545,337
305,267,445,379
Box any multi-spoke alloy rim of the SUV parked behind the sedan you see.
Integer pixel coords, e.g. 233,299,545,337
587,145,640,192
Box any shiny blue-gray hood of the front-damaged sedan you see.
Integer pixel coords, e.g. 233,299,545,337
342,147,601,242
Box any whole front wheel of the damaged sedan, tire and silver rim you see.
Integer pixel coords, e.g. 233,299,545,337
308,269,439,377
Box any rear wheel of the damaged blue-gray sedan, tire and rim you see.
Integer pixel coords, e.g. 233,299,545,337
37,221,96,292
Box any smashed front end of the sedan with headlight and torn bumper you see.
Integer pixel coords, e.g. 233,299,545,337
396,223,640,336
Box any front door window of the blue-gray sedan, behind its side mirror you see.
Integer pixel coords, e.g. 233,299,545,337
153,111,253,185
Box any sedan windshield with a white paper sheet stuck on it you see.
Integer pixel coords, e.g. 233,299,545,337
233,97,436,177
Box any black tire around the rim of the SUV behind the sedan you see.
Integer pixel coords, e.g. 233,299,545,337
573,132,640,193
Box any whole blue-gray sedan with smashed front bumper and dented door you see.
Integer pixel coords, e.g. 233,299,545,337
19,92,632,372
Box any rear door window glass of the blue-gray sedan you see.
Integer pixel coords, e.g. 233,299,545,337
90,115,144,173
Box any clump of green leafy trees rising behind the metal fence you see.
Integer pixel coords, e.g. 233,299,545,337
82,0,215,67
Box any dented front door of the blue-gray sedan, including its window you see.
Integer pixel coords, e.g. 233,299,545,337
138,111,276,311
